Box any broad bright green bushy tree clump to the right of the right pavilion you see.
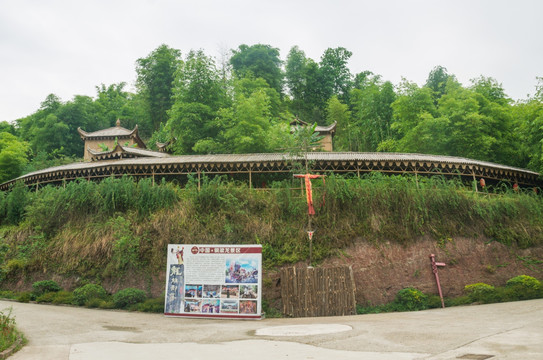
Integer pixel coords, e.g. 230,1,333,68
386,77,522,165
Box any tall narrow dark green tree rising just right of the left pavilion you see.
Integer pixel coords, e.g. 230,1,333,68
136,44,181,130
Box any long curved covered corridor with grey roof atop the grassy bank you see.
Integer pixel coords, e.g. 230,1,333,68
0,152,541,191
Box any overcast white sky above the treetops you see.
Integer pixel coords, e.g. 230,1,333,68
0,0,543,121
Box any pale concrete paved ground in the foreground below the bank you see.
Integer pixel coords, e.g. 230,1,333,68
0,300,543,360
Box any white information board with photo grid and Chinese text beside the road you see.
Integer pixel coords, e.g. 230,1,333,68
164,244,262,319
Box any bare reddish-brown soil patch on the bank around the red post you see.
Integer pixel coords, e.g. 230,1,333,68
267,238,543,305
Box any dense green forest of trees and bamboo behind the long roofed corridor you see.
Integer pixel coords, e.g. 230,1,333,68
0,44,543,182
